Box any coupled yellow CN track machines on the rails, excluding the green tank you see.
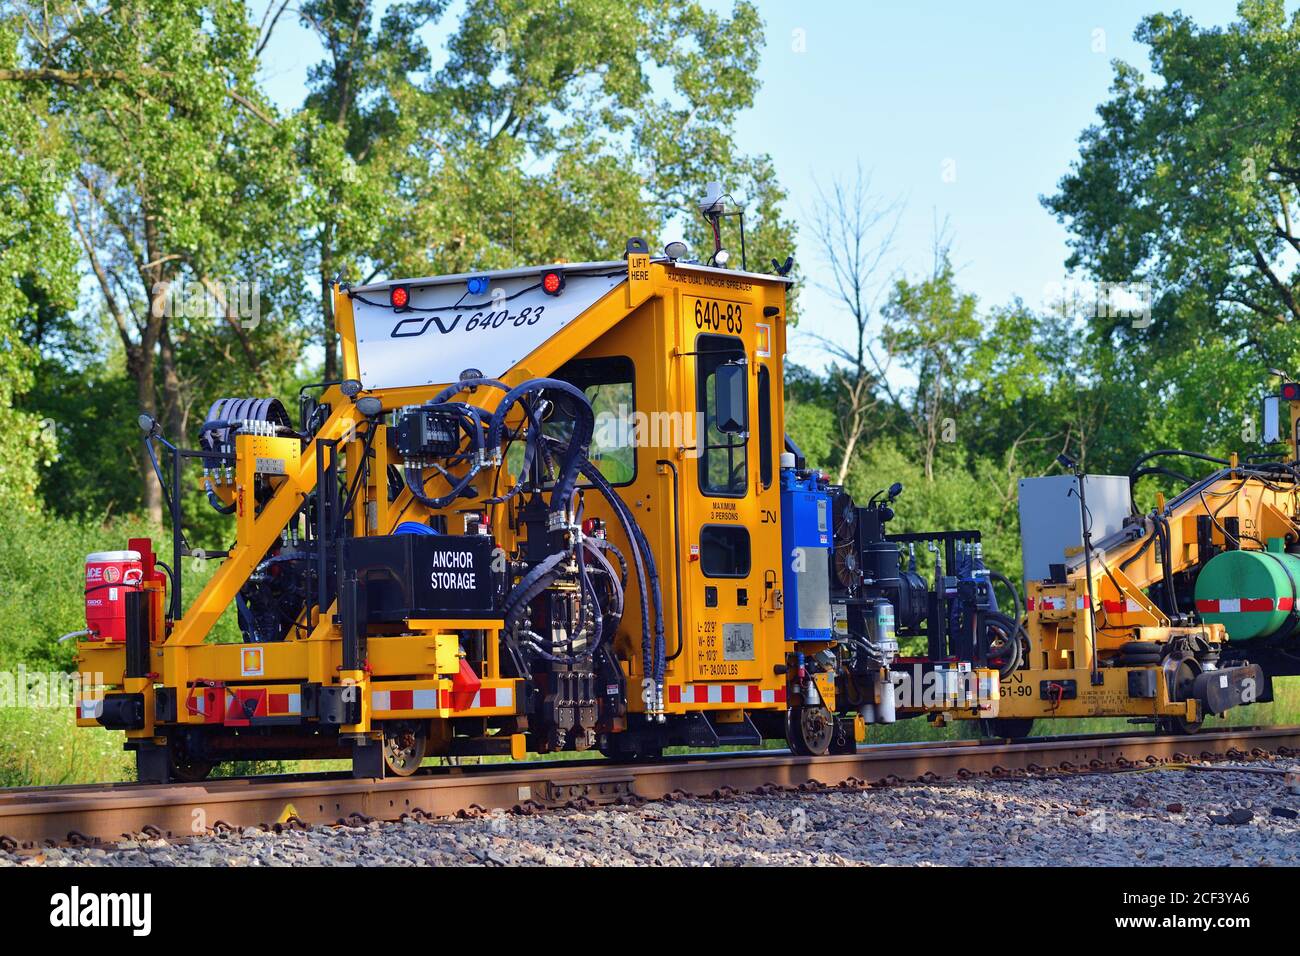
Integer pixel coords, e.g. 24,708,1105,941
78,227,1268,782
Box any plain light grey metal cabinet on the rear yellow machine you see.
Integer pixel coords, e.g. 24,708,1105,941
1021,475,1130,581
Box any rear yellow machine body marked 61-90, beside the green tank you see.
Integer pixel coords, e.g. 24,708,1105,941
982,455,1279,730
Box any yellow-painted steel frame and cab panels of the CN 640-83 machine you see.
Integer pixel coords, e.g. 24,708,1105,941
81,255,800,749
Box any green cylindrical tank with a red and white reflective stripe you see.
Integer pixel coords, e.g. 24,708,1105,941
1196,538,1300,641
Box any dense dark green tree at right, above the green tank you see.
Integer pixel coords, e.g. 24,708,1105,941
1044,0,1300,351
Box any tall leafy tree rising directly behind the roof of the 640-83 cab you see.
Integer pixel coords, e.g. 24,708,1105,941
303,0,794,375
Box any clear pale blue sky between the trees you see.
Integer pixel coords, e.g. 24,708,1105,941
263,0,1258,364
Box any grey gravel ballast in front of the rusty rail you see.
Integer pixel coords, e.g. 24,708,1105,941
10,761,1300,866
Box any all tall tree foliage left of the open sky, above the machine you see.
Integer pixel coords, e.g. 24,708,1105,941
0,0,793,522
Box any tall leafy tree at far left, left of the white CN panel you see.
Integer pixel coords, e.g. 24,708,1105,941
0,0,299,520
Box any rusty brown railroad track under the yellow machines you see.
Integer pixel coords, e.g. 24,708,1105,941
0,727,1300,852
